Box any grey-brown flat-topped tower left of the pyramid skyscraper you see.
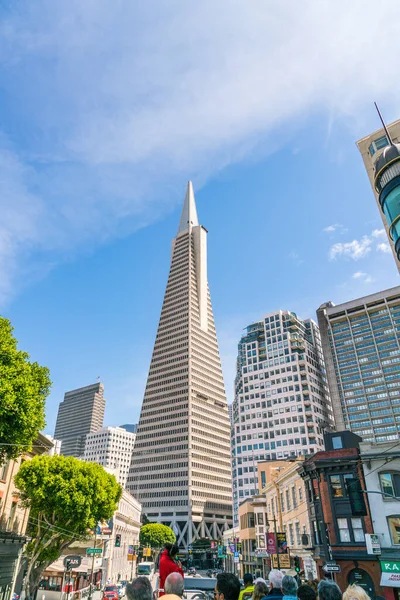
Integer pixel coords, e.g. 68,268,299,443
54,382,106,457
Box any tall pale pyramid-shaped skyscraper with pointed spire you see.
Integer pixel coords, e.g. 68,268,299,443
127,182,232,550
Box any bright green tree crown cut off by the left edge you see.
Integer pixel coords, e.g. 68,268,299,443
0,317,51,464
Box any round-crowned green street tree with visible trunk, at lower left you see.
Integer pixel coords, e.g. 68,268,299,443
15,455,122,598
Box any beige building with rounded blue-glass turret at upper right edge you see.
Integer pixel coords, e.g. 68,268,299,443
357,115,400,271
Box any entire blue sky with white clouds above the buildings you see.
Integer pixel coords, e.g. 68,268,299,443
0,0,400,432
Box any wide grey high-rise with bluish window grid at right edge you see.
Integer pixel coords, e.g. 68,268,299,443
317,286,400,443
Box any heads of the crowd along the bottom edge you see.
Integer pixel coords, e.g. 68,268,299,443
122,569,370,600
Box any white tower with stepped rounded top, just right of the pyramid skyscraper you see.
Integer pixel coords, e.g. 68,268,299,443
231,310,334,526
